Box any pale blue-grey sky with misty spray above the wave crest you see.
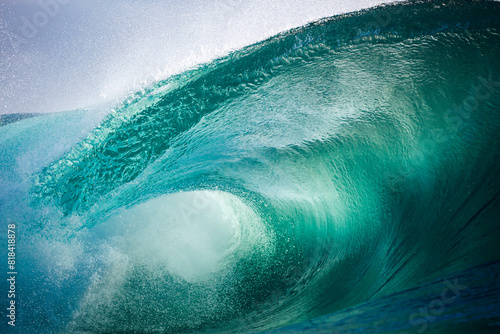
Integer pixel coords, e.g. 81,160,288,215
0,0,400,114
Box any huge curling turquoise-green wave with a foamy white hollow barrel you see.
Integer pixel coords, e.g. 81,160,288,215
0,1,500,333
